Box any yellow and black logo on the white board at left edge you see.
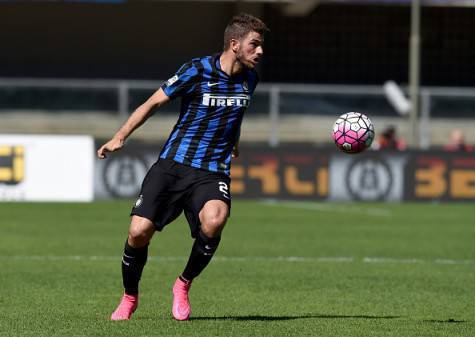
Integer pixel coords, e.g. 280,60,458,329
0,145,25,185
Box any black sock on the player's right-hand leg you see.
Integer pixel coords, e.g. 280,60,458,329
181,230,221,281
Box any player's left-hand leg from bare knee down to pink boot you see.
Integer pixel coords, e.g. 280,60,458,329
111,215,155,321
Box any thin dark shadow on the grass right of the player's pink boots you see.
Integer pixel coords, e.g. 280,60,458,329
190,314,401,321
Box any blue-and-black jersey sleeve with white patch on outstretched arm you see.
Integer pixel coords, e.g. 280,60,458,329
161,62,198,98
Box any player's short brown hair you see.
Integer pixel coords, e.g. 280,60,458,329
224,13,269,50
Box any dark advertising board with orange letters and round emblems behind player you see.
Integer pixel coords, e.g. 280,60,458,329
95,143,475,202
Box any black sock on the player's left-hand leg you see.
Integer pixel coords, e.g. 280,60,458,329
122,241,148,295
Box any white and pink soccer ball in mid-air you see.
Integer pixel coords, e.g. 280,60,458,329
332,112,374,153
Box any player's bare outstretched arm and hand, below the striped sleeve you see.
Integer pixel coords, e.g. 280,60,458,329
97,88,170,159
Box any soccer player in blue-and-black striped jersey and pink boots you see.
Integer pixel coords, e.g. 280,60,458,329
97,13,268,320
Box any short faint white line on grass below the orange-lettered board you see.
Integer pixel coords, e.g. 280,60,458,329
261,200,391,217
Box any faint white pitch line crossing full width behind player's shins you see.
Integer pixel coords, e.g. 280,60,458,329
0,255,475,265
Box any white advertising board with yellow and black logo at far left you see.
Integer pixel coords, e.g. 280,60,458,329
0,135,94,202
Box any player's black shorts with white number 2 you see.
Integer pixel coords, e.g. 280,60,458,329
130,159,231,237
